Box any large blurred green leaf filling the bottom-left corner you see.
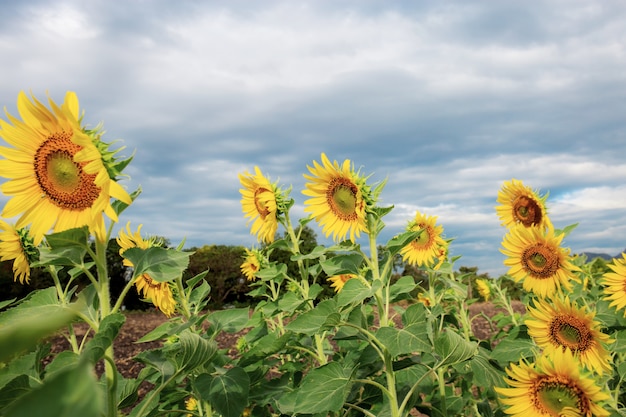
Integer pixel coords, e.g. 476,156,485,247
3,361,104,417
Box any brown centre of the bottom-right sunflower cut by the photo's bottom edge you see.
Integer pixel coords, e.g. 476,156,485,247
531,376,589,417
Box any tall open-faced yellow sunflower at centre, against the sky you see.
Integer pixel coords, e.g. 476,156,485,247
302,153,369,242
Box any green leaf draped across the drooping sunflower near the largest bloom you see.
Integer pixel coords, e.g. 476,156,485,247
124,247,191,282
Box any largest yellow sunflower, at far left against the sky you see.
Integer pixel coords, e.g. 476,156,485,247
0,92,131,245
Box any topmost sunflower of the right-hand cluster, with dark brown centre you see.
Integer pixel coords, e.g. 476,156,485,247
496,179,550,227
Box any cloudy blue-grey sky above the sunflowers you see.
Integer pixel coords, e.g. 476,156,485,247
0,0,626,275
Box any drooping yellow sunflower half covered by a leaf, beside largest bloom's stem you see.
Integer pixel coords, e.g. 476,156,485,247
116,222,176,317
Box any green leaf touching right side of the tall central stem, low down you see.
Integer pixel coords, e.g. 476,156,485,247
376,323,432,357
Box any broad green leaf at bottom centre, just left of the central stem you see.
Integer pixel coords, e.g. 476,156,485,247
279,362,350,415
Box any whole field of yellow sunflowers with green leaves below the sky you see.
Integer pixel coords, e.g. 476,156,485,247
0,92,626,417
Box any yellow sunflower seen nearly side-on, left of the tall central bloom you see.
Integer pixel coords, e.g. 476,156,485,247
239,166,278,243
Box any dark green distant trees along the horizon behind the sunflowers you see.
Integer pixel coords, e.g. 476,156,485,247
0,226,609,310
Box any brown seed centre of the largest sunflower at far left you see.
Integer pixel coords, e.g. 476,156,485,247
34,132,100,211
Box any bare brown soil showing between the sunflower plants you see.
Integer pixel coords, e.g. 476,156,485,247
44,301,525,412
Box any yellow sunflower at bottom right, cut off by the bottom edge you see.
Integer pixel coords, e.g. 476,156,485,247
495,349,610,417
